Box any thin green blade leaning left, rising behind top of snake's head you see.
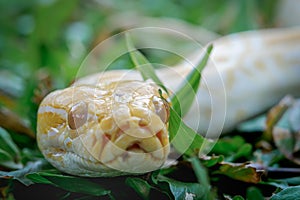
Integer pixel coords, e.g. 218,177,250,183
126,34,168,93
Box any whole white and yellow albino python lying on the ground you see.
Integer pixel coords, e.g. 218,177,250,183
37,28,300,177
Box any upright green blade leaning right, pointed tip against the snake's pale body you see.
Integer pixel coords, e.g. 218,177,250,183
171,45,213,116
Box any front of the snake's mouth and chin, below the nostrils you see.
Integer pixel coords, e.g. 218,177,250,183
99,131,169,173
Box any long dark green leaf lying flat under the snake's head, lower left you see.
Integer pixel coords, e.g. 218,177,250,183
26,172,111,196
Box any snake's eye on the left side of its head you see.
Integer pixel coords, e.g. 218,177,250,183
68,101,88,130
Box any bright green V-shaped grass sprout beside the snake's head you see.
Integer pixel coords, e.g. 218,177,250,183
126,34,212,156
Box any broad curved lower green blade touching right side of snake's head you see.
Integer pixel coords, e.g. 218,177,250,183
169,107,213,156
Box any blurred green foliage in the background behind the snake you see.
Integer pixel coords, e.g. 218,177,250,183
0,0,300,198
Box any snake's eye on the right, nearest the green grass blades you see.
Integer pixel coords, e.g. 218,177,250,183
152,96,170,123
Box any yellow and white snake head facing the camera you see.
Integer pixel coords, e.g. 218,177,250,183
37,81,170,176
